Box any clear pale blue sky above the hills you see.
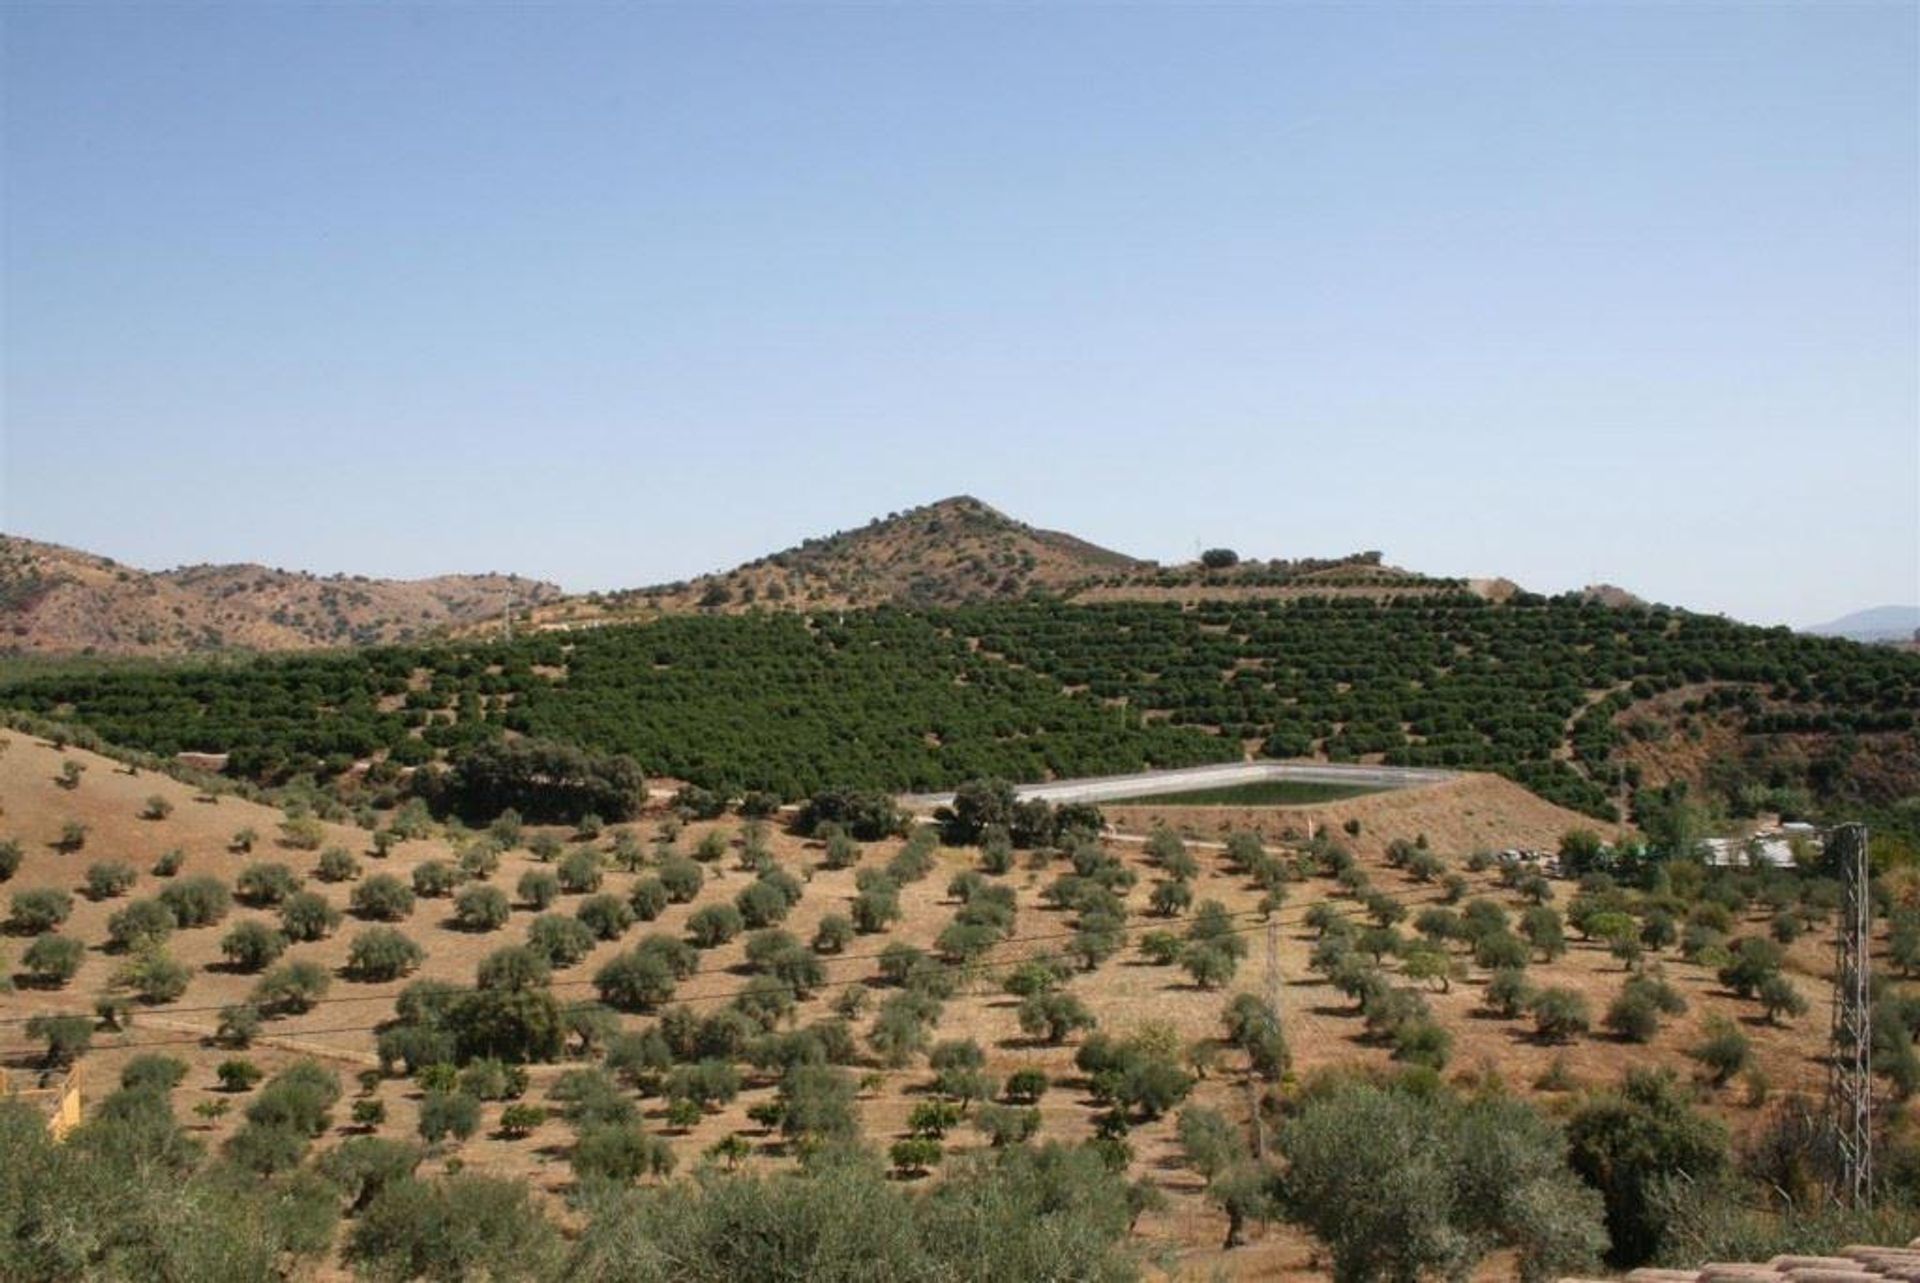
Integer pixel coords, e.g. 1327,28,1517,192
0,4,1920,622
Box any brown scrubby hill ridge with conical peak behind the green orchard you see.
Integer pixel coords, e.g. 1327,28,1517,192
0,496,1497,655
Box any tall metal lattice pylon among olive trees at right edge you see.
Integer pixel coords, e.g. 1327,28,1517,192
1826,824,1874,1208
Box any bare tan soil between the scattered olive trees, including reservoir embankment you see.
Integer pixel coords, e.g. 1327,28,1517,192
0,730,1832,1283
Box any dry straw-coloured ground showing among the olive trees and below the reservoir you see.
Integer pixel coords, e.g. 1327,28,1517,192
0,732,1858,1279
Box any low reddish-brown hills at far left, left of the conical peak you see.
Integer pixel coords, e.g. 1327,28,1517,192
0,536,561,655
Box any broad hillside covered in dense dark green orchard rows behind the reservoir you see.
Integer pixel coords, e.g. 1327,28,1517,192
0,593,1920,818
